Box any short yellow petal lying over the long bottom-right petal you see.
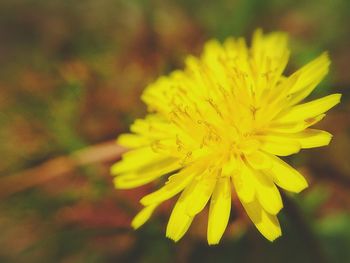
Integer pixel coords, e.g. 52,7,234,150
253,171,283,215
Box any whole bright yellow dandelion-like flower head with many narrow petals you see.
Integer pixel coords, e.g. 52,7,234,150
111,30,341,244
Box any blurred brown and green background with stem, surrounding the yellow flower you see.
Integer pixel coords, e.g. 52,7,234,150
0,0,350,263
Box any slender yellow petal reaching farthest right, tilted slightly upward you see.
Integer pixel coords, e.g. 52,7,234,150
276,93,341,122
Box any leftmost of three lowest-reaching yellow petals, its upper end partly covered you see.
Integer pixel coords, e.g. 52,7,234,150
166,197,193,242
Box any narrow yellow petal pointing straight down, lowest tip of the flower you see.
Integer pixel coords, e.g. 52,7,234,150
207,177,231,245
